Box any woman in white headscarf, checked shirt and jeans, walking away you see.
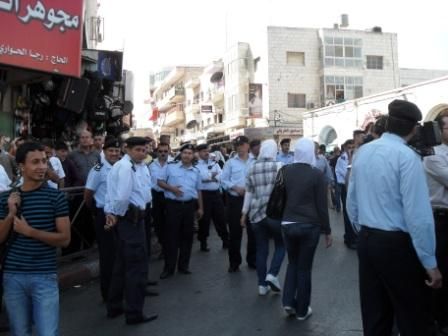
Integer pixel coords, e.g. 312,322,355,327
241,140,285,295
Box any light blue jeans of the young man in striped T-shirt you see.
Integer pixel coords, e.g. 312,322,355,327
3,273,59,336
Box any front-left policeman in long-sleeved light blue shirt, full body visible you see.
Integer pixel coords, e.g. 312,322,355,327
104,137,157,324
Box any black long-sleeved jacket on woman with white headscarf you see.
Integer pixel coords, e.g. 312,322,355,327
282,163,331,234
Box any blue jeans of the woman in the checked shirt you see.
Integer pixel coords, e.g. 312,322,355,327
251,217,285,286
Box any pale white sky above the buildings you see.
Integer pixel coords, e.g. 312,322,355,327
99,0,448,126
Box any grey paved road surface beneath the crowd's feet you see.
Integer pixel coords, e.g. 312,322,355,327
61,210,362,336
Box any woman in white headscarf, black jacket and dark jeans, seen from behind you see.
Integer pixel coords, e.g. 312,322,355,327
279,138,332,321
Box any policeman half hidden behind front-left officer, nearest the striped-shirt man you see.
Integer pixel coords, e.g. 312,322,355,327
84,139,121,301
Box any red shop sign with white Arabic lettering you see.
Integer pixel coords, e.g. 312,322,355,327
0,0,84,77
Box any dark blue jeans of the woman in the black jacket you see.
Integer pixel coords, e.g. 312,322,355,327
282,223,320,316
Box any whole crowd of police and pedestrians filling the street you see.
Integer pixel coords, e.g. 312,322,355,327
0,101,448,336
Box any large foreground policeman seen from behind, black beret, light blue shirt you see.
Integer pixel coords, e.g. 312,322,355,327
347,100,440,336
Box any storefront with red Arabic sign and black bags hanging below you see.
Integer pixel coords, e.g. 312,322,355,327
0,0,132,144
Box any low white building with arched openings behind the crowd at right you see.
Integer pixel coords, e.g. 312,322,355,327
303,76,448,147
